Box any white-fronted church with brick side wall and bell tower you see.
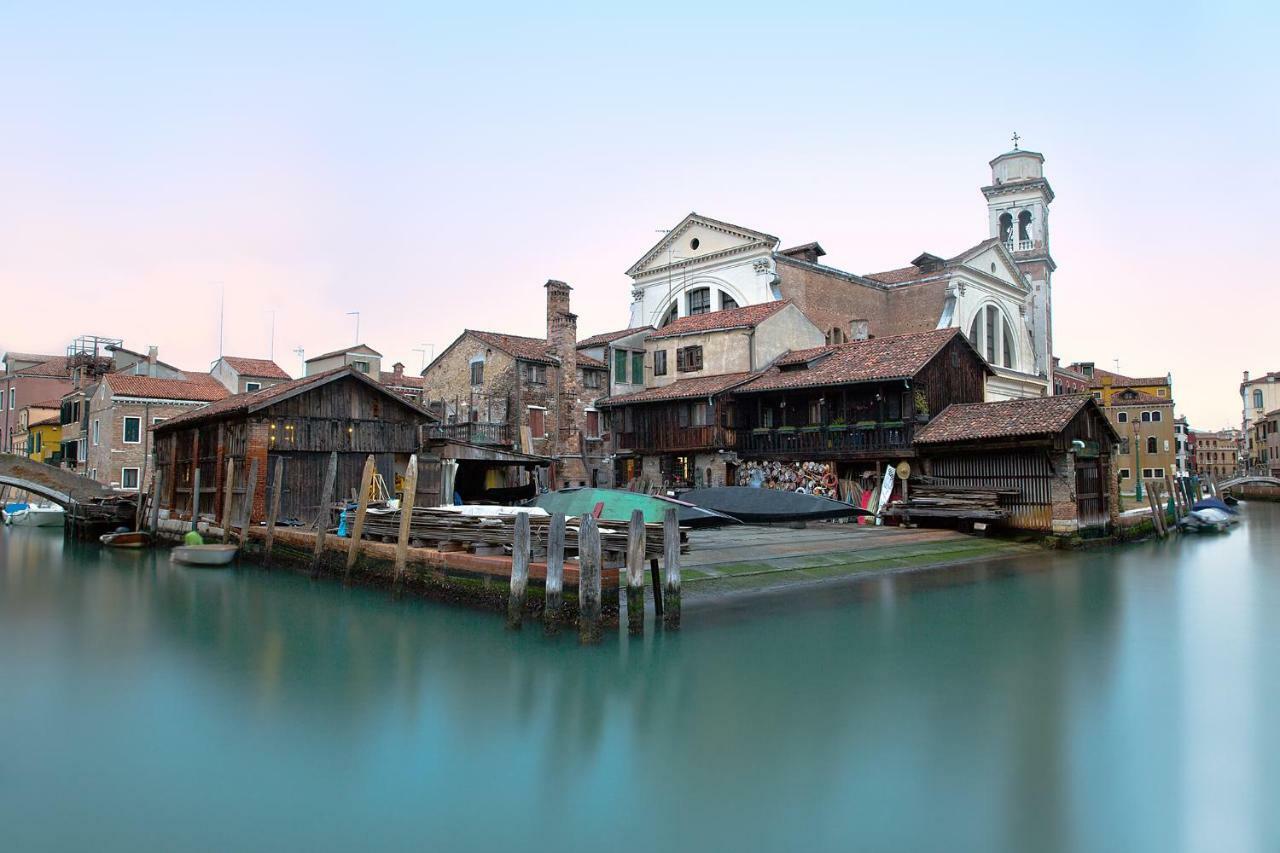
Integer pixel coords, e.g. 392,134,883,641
627,145,1055,401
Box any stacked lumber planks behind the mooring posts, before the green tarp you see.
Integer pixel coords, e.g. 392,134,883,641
355,507,685,557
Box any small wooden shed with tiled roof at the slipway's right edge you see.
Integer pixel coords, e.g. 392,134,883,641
915,394,1120,534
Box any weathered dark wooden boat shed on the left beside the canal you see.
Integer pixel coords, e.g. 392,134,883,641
152,366,439,524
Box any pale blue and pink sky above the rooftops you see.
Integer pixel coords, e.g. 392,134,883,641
0,3,1280,429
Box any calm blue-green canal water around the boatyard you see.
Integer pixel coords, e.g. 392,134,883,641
0,505,1280,852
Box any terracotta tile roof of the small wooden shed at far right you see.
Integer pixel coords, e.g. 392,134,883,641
915,394,1096,444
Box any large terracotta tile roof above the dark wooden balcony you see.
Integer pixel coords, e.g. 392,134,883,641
739,329,986,393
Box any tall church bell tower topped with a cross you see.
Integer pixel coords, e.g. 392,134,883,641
982,133,1057,388
